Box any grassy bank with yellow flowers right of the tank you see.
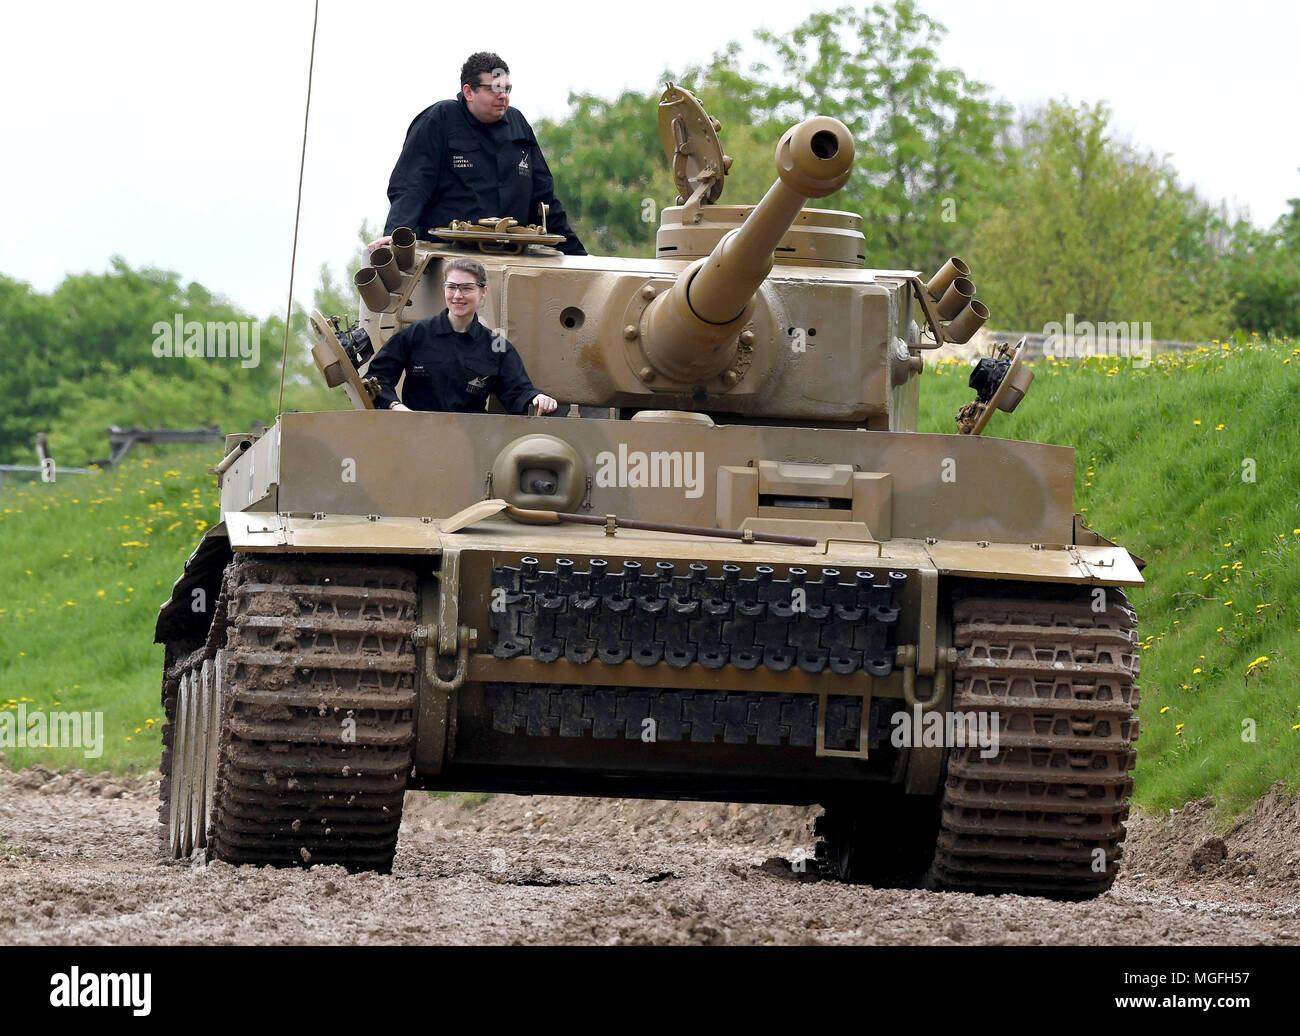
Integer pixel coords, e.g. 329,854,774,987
920,331,1300,815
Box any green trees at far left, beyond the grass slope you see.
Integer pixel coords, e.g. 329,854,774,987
0,257,342,467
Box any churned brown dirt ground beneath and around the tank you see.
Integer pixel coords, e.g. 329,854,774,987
0,770,1300,946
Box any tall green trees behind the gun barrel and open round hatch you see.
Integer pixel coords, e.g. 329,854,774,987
538,0,1009,269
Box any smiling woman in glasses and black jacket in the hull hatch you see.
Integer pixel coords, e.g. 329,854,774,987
367,259,558,413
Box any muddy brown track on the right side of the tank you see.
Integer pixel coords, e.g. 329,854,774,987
931,588,1140,898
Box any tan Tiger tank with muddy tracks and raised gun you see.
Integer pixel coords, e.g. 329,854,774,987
156,84,1143,898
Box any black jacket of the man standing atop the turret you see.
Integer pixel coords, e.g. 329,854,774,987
384,96,586,255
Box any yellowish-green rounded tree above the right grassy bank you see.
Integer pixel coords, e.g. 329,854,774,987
974,101,1230,341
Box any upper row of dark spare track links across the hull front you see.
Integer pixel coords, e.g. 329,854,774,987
490,558,907,676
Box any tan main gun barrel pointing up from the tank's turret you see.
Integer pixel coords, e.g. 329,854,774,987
644,116,854,382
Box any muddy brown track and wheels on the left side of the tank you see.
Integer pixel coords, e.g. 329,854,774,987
160,556,416,872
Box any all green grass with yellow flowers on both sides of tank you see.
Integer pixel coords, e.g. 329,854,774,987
0,342,1300,814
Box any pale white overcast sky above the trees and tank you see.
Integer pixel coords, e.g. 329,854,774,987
0,0,1300,316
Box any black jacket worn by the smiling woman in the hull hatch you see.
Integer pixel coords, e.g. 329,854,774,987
367,309,537,413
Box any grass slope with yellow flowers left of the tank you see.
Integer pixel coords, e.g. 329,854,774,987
0,446,220,773
